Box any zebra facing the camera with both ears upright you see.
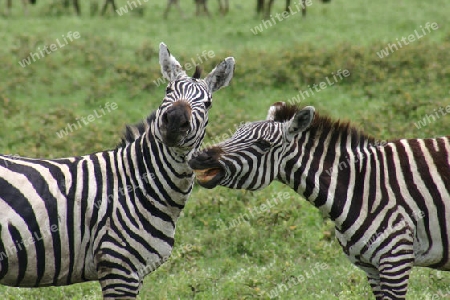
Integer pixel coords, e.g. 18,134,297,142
0,43,234,299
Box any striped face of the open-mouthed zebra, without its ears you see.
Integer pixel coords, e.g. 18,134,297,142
189,121,284,190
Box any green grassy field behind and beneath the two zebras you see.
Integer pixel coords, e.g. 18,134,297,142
0,0,450,300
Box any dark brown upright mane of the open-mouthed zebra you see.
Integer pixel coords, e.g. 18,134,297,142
273,102,375,142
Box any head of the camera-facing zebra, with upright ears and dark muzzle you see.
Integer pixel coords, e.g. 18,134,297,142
154,43,234,150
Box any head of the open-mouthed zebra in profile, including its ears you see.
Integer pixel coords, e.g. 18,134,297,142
189,102,315,190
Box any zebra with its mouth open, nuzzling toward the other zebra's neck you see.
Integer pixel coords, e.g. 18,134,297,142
189,102,450,299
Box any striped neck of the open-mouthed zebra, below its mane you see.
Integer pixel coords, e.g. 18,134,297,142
280,132,378,228
